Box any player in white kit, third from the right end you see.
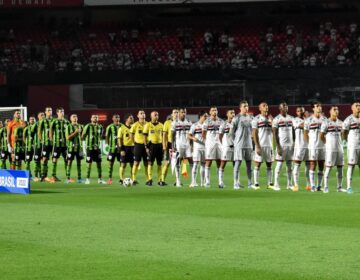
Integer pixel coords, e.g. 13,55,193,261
304,102,327,192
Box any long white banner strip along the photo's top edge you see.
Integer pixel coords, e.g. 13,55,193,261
85,0,284,6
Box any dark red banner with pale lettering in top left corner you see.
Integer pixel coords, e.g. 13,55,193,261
0,0,83,8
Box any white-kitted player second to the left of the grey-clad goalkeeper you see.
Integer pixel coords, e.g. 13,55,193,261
202,106,223,188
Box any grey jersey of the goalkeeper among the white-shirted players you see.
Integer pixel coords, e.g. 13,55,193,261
232,114,254,149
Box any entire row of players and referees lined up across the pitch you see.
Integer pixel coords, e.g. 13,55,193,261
0,101,360,193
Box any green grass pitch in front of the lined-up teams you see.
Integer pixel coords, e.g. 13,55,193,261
0,161,360,280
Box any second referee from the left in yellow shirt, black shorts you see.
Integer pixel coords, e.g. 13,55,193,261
130,110,149,185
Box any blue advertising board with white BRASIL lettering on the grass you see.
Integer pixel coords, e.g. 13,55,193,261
0,169,30,194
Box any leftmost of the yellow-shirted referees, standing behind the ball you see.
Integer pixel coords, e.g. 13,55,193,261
118,114,134,184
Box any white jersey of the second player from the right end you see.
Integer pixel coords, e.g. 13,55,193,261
321,119,344,152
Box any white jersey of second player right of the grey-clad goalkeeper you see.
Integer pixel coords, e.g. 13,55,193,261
272,114,294,147
